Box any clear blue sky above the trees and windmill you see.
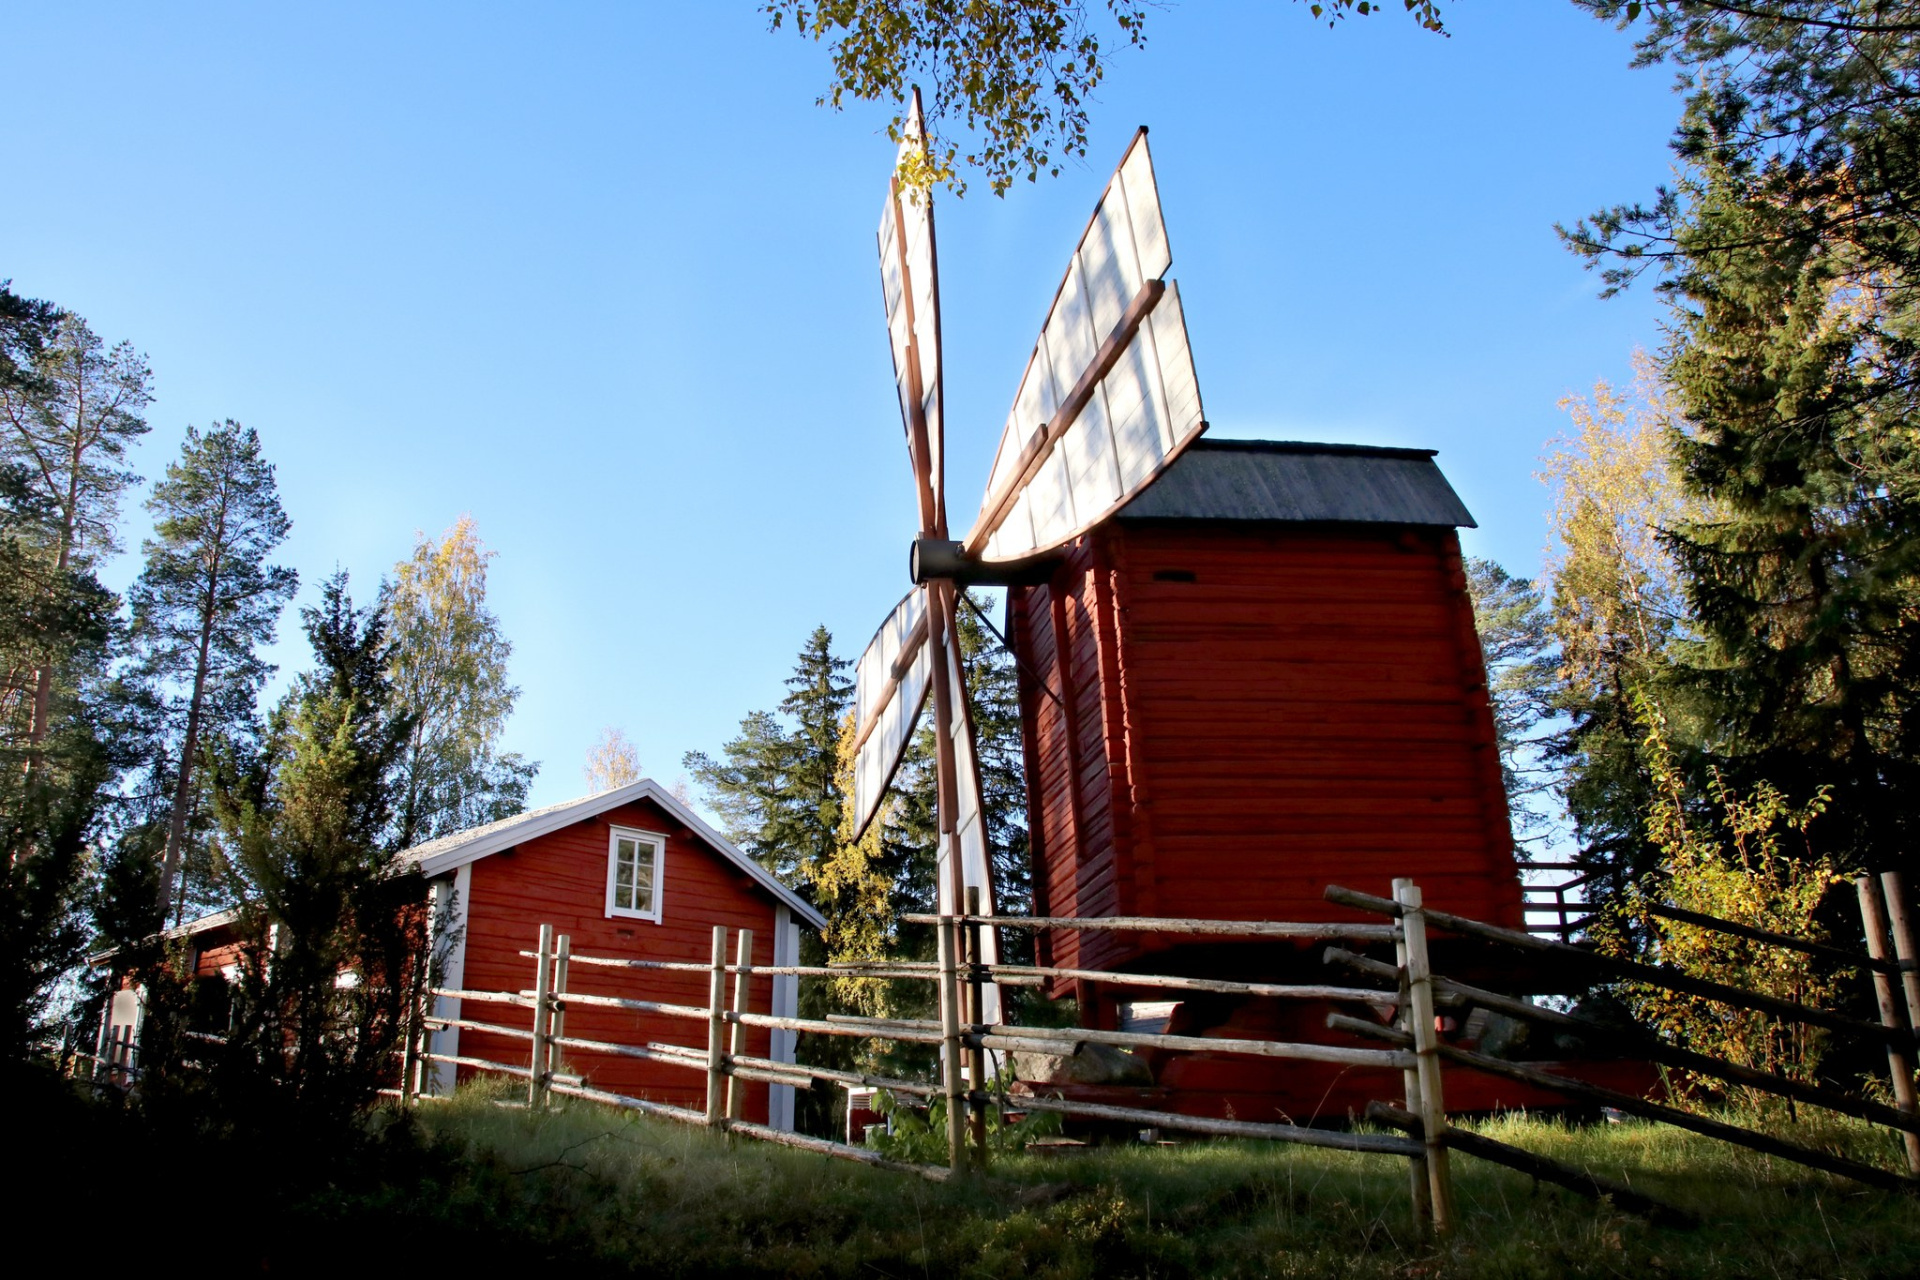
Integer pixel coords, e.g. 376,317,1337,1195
0,0,1678,802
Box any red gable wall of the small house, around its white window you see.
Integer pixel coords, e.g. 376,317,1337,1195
461,802,774,1123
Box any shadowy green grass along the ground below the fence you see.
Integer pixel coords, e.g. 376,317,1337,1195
341,1090,1920,1280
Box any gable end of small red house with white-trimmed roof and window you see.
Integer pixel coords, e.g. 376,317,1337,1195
403,781,826,1128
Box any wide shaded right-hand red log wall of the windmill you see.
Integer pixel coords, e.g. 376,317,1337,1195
1117,524,1521,923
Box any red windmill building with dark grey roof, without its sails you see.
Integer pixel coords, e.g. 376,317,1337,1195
1008,439,1523,1119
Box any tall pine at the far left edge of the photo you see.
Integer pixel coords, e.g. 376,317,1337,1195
0,295,148,1061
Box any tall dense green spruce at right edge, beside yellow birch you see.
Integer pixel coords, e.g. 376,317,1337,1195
1667,152,1920,865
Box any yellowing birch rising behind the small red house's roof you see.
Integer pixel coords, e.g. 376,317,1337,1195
388,516,540,848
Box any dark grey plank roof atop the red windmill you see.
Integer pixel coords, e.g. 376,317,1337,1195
1117,439,1476,528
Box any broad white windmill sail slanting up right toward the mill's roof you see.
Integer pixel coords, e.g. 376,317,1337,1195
966,130,1206,562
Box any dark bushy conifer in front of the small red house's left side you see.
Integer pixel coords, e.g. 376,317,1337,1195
207,574,426,1128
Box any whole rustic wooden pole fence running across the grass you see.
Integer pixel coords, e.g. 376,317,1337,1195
403,881,1920,1232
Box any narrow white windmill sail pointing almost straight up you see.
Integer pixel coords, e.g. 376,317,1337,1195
879,90,947,533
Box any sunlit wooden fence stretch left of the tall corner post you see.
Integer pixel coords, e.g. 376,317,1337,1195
411,902,1450,1230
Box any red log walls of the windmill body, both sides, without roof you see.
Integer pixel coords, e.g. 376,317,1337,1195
1010,522,1523,997
